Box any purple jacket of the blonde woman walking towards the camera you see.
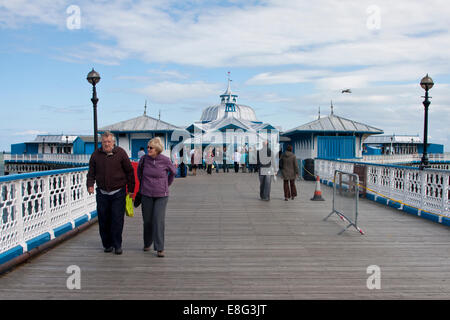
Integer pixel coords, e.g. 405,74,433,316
137,154,176,197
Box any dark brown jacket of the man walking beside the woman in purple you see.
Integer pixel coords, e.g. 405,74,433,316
87,146,135,192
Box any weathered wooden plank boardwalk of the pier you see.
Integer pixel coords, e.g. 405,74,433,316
0,172,450,300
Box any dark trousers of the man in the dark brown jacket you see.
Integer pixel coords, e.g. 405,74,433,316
96,188,126,249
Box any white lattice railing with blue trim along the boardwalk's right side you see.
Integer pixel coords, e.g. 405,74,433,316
314,159,450,217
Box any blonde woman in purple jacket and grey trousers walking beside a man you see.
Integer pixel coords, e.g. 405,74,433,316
137,137,176,257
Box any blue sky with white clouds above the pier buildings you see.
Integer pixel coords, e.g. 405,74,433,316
0,0,450,151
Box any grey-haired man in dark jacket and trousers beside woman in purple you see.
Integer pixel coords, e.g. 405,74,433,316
86,131,135,254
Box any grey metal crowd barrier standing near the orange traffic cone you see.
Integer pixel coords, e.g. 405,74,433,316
323,170,364,234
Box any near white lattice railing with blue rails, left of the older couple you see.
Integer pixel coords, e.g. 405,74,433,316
0,167,96,264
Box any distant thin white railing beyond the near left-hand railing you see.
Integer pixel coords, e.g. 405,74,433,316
4,153,91,165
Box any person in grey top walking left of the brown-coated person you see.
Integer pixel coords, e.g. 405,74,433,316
257,140,274,201
